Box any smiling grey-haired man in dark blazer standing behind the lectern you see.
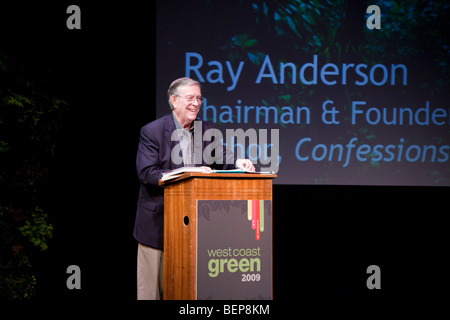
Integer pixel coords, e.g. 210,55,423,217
133,78,255,300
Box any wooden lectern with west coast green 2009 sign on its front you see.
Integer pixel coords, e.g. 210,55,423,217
160,173,276,300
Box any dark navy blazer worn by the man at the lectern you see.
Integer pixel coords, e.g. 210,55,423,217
133,114,236,250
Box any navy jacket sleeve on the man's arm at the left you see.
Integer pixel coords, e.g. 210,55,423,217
136,126,169,186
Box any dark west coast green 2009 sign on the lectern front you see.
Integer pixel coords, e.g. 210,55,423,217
197,200,272,300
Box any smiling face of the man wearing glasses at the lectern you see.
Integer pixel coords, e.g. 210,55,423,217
170,85,202,129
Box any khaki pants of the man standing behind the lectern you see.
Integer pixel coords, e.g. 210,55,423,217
137,243,163,300
